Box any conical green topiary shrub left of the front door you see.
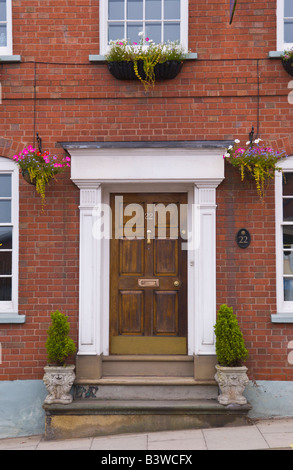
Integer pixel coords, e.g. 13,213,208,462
46,310,76,366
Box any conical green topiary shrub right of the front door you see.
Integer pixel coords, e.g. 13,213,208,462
214,304,248,367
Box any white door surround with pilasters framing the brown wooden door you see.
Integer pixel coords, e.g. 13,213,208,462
62,142,227,370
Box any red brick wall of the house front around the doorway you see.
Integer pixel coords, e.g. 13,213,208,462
0,0,293,380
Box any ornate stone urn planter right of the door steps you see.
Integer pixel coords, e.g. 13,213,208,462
215,365,249,405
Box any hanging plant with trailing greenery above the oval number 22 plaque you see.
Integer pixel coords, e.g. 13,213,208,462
223,139,287,200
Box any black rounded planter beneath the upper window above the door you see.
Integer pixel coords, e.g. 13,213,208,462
108,60,183,80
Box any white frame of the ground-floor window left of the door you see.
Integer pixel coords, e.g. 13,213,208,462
0,157,21,323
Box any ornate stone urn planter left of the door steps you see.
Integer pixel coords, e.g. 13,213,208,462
43,365,75,405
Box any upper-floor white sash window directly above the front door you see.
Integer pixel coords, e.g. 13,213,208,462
100,0,188,54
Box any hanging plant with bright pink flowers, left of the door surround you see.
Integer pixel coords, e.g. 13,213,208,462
13,145,70,209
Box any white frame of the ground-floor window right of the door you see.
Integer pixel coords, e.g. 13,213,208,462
271,156,293,323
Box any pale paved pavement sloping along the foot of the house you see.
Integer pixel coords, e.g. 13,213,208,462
0,418,293,452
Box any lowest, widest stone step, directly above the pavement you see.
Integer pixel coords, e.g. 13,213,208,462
43,399,251,440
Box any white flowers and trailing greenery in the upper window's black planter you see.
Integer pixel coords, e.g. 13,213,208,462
105,32,186,90
